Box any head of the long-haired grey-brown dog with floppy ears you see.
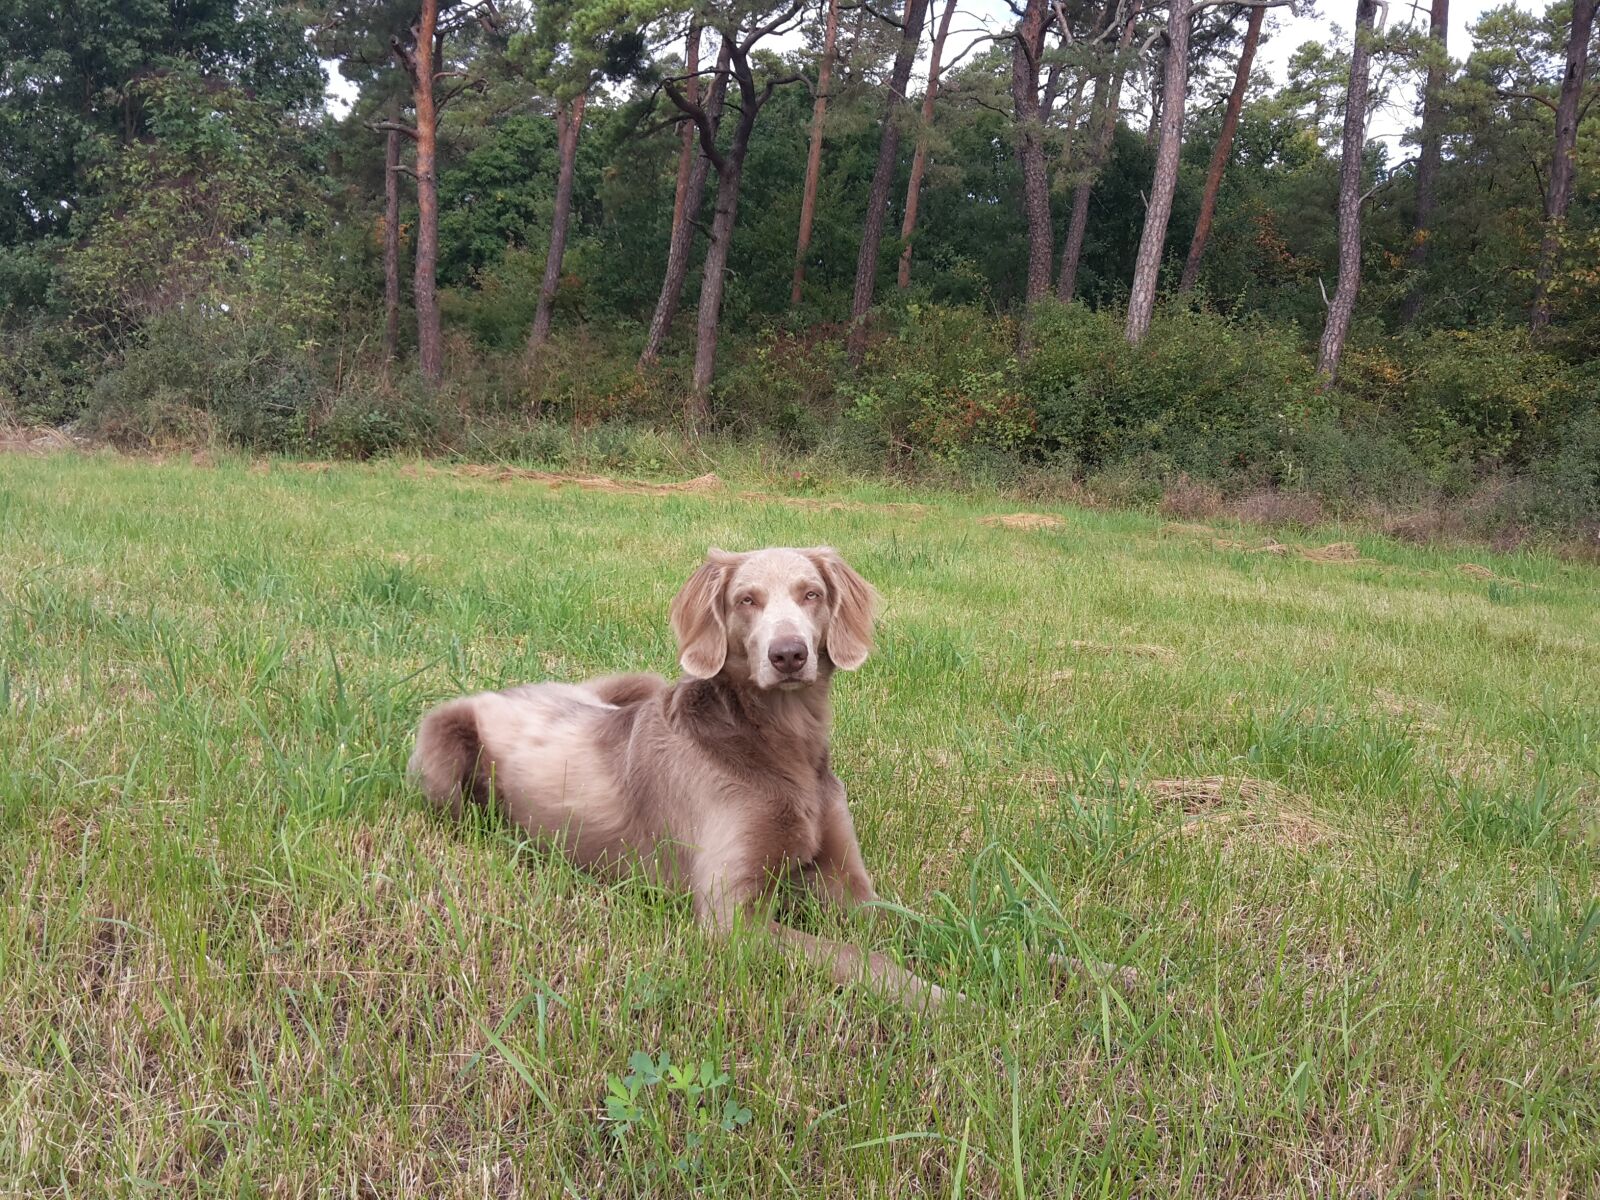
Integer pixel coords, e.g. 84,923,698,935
672,546,878,690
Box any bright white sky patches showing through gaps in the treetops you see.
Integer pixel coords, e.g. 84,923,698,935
323,0,1542,148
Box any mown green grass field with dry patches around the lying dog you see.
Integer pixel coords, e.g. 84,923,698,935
0,454,1600,1198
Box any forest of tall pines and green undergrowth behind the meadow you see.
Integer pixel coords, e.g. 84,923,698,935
0,0,1600,546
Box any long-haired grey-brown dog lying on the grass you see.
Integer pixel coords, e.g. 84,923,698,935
410,546,944,1010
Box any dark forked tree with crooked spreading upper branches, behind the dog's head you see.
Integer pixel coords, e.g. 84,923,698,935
664,0,805,409
